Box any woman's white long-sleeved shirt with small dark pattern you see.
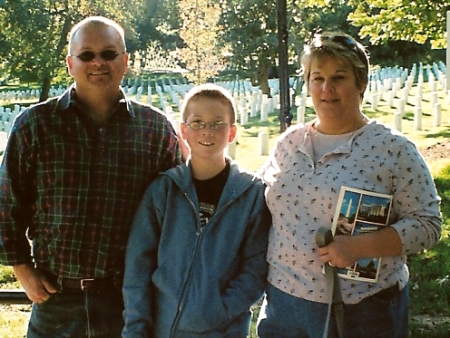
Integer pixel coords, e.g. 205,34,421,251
261,121,442,304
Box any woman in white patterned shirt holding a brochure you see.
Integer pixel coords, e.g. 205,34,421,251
258,33,442,338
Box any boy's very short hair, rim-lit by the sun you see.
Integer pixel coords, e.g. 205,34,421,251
181,83,236,124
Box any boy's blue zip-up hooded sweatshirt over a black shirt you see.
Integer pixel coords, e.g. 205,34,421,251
123,162,271,338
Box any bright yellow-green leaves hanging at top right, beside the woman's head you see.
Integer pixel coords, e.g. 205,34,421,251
349,0,450,48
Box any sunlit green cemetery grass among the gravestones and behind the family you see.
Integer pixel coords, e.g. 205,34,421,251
0,81,450,338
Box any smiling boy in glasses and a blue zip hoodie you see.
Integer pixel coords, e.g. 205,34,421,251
123,84,271,338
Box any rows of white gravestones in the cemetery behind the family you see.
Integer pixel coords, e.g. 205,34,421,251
0,65,450,155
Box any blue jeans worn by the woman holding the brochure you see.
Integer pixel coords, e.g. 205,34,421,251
258,284,409,338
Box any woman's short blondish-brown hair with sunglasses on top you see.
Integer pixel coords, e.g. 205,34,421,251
301,32,370,99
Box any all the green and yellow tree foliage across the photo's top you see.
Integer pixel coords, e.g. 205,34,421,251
0,0,450,99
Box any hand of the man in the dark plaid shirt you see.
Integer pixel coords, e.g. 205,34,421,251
13,264,57,304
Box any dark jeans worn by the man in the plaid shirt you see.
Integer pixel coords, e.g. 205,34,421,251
27,290,123,338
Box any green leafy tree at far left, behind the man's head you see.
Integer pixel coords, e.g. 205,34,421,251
0,0,143,101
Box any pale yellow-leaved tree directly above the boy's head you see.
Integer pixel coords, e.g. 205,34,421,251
178,0,223,84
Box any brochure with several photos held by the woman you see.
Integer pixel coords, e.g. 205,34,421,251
332,186,392,283
